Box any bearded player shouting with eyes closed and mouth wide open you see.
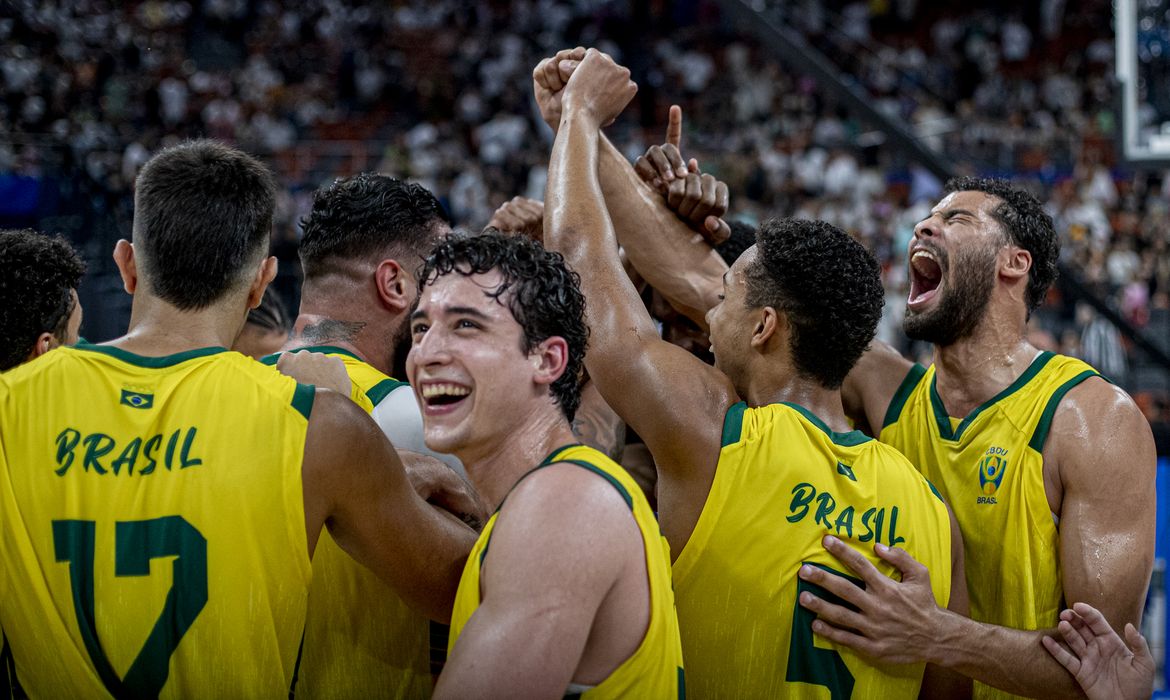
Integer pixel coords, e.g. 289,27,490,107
811,178,1155,696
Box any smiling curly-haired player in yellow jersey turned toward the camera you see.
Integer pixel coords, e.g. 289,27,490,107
407,232,683,699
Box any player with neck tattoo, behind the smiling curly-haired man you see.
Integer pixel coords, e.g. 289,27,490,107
262,173,470,700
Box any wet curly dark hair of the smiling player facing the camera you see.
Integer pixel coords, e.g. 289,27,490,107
419,227,589,421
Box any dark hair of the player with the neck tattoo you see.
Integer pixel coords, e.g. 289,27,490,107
300,172,449,279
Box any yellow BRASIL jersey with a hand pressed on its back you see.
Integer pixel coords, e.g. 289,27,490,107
674,402,951,700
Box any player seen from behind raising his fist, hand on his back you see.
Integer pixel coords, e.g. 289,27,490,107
545,49,965,698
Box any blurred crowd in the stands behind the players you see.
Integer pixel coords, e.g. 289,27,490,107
0,0,1170,411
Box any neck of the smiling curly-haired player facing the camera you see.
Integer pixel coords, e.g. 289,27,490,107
455,406,578,510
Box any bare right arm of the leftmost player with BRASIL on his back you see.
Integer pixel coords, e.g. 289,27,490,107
302,391,476,622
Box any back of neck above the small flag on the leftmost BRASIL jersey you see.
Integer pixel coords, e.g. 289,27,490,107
110,293,247,357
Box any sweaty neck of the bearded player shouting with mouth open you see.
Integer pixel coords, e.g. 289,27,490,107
934,308,1039,416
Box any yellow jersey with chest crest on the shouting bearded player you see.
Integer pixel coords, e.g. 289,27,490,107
881,352,1100,698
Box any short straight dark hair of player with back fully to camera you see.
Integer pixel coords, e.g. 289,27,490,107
133,139,276,310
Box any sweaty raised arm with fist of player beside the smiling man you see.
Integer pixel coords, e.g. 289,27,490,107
544,50,737,505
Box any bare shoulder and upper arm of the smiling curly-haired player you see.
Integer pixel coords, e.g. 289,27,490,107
434,465,649,699
